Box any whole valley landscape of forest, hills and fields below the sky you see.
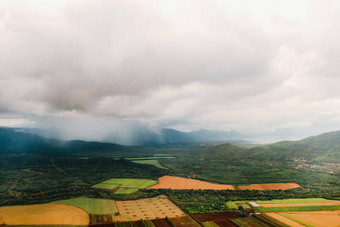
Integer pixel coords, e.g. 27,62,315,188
0,131,340,226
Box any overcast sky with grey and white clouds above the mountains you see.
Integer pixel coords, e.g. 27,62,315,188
0,0,340,140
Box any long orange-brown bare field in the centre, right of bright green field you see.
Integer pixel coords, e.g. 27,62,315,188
148,176,234,190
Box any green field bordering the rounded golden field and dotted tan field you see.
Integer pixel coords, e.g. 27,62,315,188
53,197,118,214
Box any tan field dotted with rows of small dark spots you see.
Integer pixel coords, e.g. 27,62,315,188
112,195,186,222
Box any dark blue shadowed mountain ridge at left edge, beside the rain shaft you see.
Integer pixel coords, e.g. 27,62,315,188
0,128,135,155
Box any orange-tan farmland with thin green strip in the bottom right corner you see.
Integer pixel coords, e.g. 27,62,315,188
267,210,340,227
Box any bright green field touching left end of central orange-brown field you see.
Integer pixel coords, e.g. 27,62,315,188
92,178,157,194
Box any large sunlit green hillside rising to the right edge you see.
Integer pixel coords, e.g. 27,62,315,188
249,131,340,163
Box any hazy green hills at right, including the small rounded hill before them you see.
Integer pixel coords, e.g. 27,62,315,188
202,131,340,163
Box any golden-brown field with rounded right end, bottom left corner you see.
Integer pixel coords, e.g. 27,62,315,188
0,203,90,225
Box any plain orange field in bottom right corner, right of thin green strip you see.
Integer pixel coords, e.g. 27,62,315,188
287,210,340,227
